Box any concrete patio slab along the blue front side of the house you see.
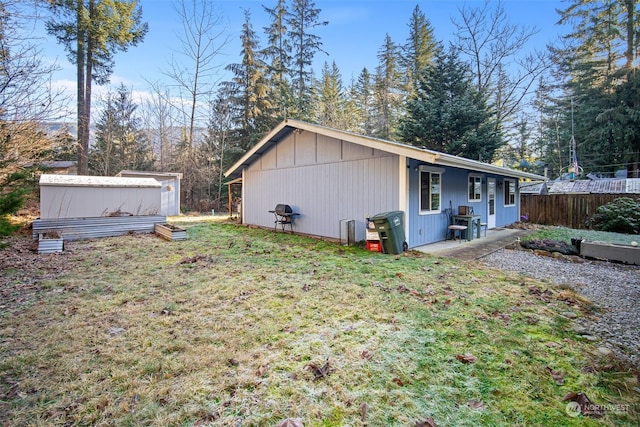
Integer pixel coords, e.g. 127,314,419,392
414,228,529,261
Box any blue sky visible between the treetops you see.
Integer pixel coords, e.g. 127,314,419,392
35,0,567,105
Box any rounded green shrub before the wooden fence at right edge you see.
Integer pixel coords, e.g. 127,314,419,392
591,197,640,234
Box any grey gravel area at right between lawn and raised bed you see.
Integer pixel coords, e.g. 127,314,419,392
480,249,640,367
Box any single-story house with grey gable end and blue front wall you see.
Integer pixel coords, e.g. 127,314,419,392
225,120,544,248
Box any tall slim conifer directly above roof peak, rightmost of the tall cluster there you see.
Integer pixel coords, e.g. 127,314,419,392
286,0,328,120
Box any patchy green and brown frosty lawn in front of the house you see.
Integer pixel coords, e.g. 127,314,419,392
0,223,640,427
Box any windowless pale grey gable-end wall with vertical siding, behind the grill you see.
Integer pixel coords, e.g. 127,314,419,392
243,132,399,240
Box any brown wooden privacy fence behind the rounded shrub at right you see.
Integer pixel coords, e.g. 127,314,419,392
520,194,638,229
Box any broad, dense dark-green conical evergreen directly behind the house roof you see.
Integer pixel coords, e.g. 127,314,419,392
400,47,502,161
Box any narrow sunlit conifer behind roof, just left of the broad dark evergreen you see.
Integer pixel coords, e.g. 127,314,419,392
373,34,404,139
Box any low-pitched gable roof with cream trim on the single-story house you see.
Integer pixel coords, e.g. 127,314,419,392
224,119,546,180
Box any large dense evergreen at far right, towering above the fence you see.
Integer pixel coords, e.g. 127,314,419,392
553,0,640,173
